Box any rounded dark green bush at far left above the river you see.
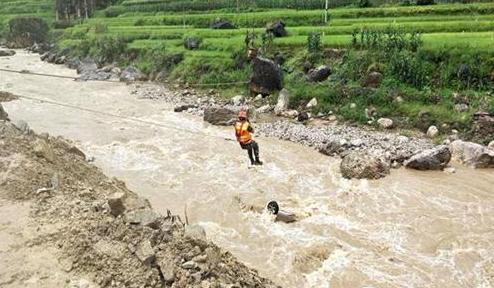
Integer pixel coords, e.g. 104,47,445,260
7,17,50,48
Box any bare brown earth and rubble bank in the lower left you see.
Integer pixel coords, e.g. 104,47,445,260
0,97,276,288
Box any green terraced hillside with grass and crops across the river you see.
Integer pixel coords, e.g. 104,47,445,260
0,0,494,136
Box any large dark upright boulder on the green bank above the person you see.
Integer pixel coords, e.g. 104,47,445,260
249,57,283,95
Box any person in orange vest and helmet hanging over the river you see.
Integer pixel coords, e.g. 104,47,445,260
235,110,262,165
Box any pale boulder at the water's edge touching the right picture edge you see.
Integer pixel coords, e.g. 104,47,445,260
449,140,494,168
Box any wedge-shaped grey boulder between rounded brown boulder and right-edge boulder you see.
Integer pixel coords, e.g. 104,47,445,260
404,145,451,170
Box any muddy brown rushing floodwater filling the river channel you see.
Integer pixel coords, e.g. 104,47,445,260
0,51,494,288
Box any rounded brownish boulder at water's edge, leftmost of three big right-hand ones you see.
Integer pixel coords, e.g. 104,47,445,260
340,152,389,179
